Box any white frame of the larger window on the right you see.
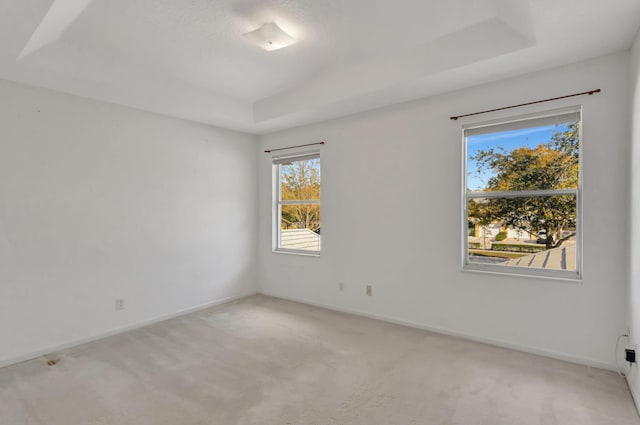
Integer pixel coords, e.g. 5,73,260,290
462,105,583,281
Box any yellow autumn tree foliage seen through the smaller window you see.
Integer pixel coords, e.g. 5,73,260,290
280,159,320,232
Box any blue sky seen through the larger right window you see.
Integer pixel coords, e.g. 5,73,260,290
467,124,567,190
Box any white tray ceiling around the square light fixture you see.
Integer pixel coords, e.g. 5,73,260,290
0,0,640,133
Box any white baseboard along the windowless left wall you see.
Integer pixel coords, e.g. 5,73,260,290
0,291,257,368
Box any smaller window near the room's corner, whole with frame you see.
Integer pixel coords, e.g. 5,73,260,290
273,152,321,255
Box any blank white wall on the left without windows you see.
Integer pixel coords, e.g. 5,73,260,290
0,81,257,365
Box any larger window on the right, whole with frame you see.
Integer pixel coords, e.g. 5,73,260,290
463,108,581,279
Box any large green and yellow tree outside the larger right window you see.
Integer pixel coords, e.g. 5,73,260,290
469,124,579,248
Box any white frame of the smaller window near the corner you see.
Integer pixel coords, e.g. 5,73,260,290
271,150,322,257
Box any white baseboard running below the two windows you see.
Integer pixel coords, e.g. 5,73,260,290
258,290,616,371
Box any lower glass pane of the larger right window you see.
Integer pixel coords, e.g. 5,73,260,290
467,195,577,271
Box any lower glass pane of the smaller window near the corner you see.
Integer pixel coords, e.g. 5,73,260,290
280,204,320,252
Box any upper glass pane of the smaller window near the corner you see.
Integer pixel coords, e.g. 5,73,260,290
279,158,320,201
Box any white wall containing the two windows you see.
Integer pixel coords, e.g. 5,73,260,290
258,53,629,368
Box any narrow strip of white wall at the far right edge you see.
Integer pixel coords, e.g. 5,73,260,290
621,29,640,405
